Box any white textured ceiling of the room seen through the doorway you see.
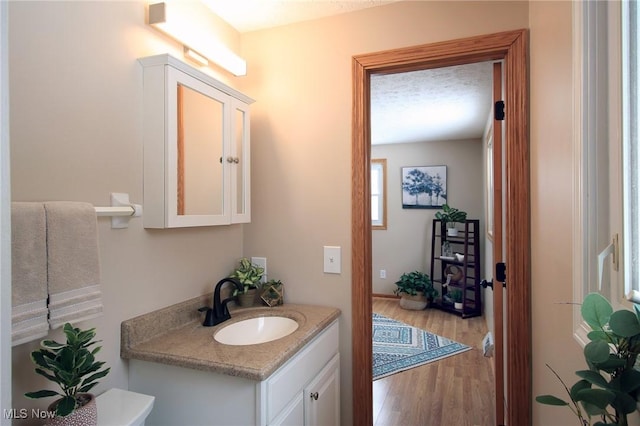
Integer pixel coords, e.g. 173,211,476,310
371,62,493,145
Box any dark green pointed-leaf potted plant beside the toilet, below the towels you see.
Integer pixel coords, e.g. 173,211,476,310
25,323,111,417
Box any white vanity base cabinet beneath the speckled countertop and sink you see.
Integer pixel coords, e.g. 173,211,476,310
129,320,340,426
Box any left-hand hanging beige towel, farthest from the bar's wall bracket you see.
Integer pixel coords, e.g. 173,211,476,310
11,202,49,346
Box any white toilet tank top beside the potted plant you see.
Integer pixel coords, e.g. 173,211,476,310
96,388,155,426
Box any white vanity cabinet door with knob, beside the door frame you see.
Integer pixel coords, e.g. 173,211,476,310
303,354,340,426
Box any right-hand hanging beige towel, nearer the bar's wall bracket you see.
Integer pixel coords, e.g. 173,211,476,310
44,201,102,329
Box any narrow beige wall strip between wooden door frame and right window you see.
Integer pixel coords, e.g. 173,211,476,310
529,1,585,426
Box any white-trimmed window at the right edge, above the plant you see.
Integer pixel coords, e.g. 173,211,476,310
574,0,640,343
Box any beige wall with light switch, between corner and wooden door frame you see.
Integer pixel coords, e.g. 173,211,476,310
242,1,528,424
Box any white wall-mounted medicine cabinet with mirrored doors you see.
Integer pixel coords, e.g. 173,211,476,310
139,55,253,228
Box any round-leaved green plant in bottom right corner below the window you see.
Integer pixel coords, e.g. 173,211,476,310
536,293,640,426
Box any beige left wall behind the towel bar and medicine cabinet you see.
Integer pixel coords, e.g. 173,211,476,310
9,2,243,423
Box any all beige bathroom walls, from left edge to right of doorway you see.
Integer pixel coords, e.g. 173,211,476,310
9,1,596,425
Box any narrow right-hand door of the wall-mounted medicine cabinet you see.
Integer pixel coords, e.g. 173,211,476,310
227,99,251,223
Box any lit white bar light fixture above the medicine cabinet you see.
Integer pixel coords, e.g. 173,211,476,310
149,2,247,76
